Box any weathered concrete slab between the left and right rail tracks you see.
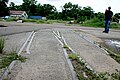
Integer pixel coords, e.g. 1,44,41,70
11,30,72,80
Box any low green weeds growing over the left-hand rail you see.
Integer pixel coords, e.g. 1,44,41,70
0,52,26,69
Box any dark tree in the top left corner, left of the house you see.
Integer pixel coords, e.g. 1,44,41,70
0,0,9,17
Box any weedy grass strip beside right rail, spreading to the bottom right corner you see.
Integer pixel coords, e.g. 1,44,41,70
69,54,120,80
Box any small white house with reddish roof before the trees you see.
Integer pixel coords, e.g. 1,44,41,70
10,10,28,19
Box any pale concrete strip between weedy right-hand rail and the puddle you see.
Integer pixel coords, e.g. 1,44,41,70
61,30,120,73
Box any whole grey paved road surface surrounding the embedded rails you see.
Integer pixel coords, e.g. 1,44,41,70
0,22,120,80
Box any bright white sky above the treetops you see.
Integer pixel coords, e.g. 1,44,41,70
9,0,120,13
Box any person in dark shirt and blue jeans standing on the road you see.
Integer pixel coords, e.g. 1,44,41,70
103,7,113,33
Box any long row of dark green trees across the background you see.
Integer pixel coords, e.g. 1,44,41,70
6,0,103,23
